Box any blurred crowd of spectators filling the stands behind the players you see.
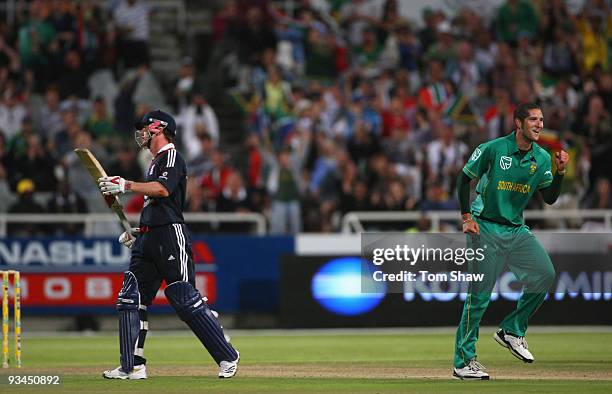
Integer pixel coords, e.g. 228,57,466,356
0,0,612,233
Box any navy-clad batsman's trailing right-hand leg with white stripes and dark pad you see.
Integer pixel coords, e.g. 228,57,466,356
158,224,239,378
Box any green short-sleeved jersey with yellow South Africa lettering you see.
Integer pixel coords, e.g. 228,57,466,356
463,133,553,226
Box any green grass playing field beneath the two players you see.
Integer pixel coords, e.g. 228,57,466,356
0,328,612,394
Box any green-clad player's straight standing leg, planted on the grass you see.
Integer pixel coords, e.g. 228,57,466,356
453,221,504,379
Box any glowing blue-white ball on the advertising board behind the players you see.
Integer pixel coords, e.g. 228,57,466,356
311,257,387,316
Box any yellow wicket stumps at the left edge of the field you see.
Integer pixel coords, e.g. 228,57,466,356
0,270,21,368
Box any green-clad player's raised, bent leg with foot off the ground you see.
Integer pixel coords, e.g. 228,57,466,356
494,227,555,362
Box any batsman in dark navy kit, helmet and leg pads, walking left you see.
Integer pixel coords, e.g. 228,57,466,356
98,110,240,379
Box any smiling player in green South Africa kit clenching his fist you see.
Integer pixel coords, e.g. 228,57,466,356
453,103,569,380
